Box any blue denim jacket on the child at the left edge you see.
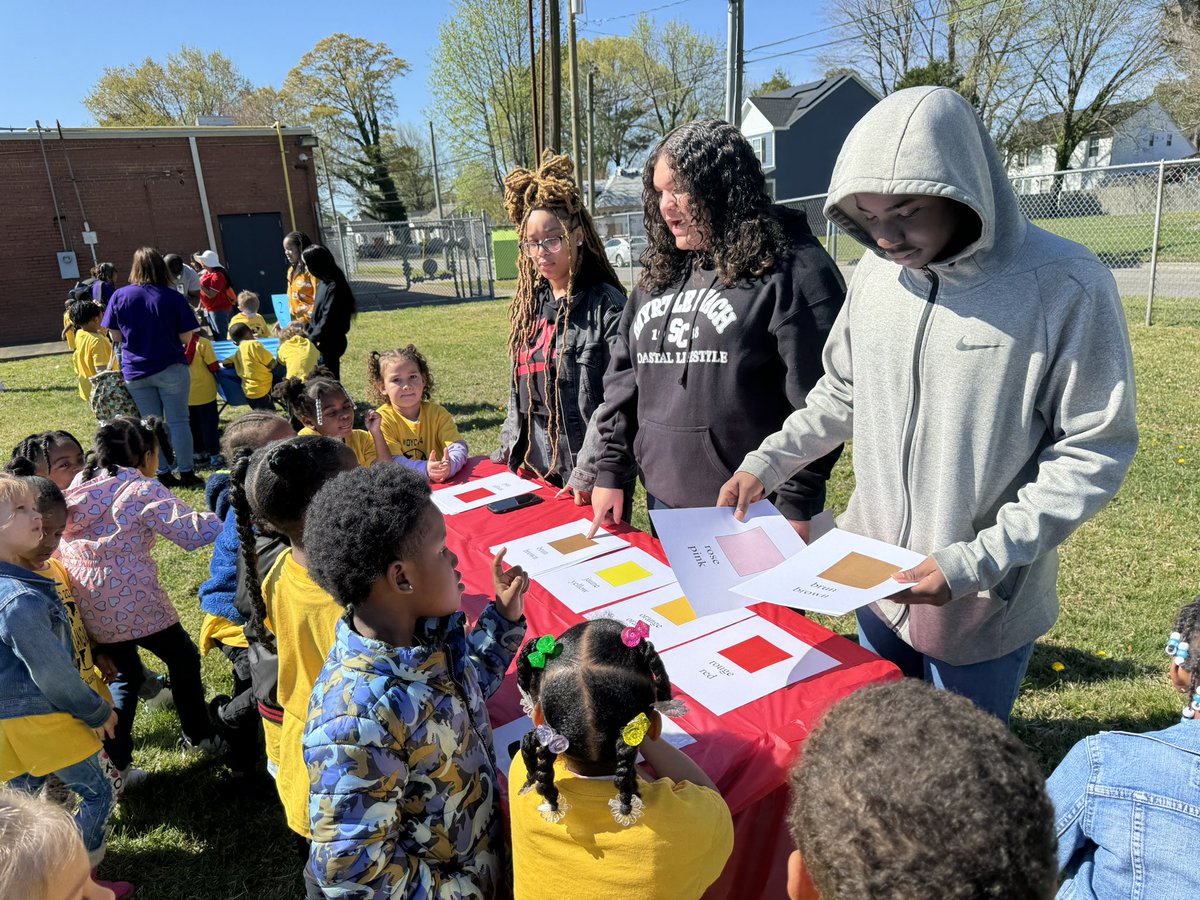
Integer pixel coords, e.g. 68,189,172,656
0,562,110,728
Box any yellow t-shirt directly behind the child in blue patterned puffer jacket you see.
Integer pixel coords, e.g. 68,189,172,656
263,548,343,838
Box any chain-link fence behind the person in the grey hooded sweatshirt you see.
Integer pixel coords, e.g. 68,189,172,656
781,158,1200,325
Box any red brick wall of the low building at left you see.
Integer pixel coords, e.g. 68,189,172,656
0,134,318,346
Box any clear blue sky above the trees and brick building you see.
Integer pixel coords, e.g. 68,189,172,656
0,0,827,127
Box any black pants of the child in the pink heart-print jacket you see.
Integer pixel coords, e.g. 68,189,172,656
100,622,214,769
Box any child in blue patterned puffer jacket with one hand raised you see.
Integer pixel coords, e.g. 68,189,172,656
304,466,528,898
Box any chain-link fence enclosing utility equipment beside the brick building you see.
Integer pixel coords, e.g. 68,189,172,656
322,217,496,310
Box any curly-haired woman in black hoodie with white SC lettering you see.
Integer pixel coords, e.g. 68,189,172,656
592,121,845,534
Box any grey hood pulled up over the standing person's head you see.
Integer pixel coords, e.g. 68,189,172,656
824,88,1026,268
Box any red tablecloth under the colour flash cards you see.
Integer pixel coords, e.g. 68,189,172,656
436,458,900,900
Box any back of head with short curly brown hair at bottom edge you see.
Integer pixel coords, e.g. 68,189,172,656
787,679,1057,900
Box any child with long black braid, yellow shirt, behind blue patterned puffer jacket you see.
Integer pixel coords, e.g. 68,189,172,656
230,437,359,844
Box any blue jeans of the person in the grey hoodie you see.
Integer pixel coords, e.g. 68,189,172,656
858,608,1033,725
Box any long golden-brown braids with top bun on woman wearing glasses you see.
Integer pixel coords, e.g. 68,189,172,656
504,150,625,478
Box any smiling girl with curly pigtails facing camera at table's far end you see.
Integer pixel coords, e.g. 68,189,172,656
367,344,467,484
